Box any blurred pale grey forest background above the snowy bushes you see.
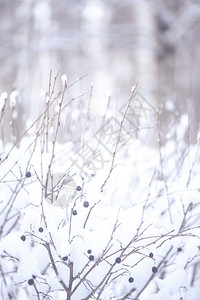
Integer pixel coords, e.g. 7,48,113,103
0,0,200,144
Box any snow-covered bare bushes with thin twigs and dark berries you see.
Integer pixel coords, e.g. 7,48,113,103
0,74,200,300
